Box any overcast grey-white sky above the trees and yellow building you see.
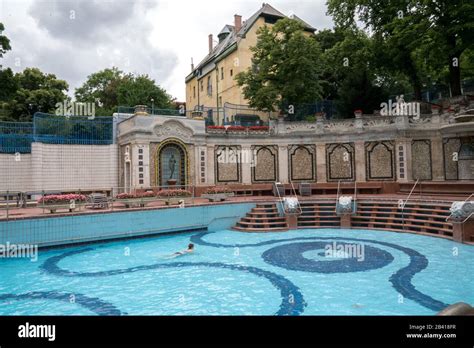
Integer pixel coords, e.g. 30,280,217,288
0,0,332,101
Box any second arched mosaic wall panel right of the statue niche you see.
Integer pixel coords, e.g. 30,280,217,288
251,145,278,183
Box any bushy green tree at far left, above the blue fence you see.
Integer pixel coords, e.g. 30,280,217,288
6,68,69,122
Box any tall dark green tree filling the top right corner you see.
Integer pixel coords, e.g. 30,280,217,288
328,0,474,99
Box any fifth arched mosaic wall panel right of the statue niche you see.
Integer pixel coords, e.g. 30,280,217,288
365,141,395,180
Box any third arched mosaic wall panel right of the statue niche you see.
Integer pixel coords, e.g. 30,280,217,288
288,145,316,181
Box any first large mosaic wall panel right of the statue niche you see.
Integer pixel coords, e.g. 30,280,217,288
214,146,242,183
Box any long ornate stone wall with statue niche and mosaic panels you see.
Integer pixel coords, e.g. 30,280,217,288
118,110,474,188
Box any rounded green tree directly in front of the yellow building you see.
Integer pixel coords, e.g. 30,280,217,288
236,18,322,111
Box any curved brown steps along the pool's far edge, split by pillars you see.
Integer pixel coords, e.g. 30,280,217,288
234,200,462,242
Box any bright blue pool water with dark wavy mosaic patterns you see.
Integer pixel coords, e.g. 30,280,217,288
0,229,474,315
